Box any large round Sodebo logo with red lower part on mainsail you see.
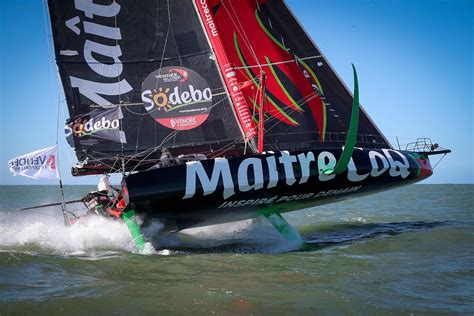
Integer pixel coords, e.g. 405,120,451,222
142,66,212,130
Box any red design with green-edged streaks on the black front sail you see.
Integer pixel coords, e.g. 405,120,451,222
202,0,325,141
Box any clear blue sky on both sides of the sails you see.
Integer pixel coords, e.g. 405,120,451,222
0,0,474,184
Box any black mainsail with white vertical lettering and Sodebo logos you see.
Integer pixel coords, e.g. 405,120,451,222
48,0,248,174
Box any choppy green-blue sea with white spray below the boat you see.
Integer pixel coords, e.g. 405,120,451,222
0,185,474,316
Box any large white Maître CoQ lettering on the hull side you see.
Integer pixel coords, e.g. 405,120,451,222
183,149,410,199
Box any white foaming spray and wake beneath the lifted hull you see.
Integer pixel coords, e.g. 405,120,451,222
0,203,297,259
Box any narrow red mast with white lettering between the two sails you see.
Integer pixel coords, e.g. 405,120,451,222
195,0,257,140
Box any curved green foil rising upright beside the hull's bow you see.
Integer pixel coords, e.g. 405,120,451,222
334,65,359,174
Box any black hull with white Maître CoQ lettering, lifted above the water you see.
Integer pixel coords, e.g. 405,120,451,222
126,149,432,229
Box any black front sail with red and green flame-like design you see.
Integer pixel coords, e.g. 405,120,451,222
196,0,390,150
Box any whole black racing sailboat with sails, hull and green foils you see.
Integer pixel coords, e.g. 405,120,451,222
42,0,449,247
